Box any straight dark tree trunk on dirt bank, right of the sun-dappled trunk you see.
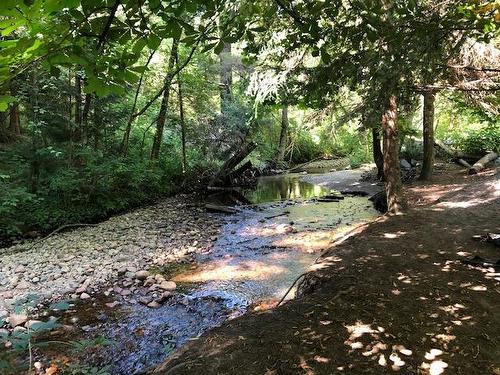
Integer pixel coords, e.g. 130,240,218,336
420,91,436,180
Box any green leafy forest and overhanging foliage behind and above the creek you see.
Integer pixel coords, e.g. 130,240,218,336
0,0,500,244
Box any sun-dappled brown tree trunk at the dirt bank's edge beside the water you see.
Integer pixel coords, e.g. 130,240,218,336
382,94,403,214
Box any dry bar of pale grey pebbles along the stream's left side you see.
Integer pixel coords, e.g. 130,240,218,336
0,195,220,311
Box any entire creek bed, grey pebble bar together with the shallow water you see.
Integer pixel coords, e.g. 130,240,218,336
0,171,377,374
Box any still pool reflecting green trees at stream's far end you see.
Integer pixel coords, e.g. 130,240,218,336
245,174,330,203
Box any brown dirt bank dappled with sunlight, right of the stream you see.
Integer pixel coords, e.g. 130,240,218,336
155,165,500,375
